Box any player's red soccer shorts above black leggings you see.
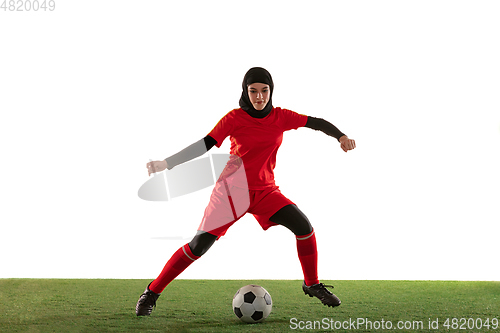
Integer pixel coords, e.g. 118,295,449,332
198,181,294,237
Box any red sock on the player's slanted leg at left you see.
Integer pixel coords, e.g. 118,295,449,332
149,244,200,294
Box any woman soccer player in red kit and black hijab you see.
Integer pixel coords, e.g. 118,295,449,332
136,67,356,316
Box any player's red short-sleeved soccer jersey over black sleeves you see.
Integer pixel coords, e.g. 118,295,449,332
208,107,307,190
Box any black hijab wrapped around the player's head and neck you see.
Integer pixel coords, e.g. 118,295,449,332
240,67,274,118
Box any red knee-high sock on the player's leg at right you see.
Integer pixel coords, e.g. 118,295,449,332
295,230,319,286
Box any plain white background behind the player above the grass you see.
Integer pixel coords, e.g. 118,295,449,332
0,0,500,280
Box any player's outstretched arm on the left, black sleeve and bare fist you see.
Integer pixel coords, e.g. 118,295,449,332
146,135,217,175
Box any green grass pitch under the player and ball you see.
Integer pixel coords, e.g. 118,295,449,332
0,279,500,333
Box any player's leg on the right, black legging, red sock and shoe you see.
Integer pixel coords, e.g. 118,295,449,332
269,205,341,306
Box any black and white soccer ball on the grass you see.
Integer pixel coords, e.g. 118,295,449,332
233,284,273,323
